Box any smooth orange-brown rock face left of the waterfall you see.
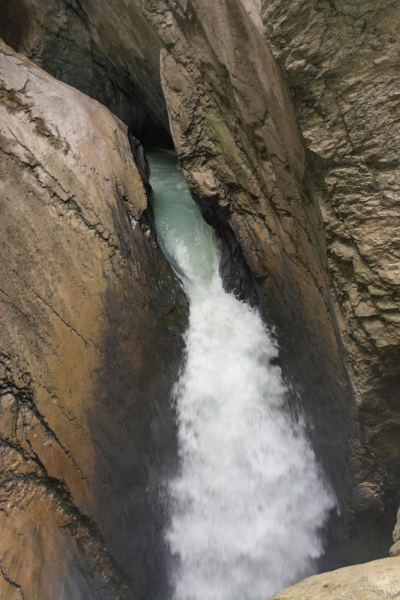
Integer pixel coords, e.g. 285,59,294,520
0,44,186,600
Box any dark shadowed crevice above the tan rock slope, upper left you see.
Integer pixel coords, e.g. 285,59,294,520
0,0,170,147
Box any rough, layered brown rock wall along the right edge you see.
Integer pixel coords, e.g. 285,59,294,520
262,0,400,564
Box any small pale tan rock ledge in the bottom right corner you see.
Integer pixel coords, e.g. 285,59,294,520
271,558,400,600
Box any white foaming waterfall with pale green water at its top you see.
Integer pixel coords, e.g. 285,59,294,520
148,150,334,600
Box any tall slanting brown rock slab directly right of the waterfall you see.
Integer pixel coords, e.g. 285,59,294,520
76,0,358,560
